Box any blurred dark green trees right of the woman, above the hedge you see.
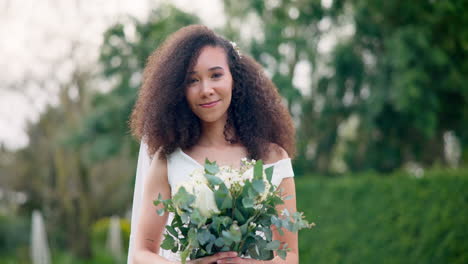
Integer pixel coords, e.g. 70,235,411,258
224,0,468,173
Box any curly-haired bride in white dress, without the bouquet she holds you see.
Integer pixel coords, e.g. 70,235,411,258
129,25,298,264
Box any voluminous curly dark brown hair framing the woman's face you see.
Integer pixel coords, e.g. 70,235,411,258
130,25,295,159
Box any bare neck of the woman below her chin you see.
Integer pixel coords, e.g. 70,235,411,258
198,116,230,147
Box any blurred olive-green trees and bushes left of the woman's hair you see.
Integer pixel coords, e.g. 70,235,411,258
4,3,198,259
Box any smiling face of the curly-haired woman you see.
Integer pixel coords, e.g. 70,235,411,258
185,46,232,123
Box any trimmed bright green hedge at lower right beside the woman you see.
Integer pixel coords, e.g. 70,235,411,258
296,170,468,264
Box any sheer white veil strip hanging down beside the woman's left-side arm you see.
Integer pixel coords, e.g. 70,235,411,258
127,140,151,264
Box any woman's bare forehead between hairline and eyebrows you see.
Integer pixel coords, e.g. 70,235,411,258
193,46,228,71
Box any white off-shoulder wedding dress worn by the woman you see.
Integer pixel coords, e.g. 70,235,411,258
128,148,294,264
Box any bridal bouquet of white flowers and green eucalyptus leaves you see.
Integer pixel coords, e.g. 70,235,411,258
154,159,313,263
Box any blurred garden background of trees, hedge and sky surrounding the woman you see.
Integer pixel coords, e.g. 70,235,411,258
0,0,468,264
